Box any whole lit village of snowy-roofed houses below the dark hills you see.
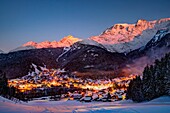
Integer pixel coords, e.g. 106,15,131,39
8,65,136,102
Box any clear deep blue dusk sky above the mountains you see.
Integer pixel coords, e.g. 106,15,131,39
0,0,170,51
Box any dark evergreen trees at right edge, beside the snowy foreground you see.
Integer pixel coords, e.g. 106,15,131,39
126,53,170,102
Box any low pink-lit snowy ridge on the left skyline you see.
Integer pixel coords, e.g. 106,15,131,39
10,35,81,52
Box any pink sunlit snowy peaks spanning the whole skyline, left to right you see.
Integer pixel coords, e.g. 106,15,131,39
11,18,170,53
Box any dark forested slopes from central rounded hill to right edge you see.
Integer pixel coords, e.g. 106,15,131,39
57,29,170,76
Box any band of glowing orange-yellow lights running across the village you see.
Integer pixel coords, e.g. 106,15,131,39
8,70,136,92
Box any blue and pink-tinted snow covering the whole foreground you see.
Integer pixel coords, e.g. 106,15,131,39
0,96,170,113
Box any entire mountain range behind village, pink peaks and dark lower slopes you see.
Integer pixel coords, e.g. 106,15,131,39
0,18,170,78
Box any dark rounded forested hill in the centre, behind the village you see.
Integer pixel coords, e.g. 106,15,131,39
57,40,127,77
